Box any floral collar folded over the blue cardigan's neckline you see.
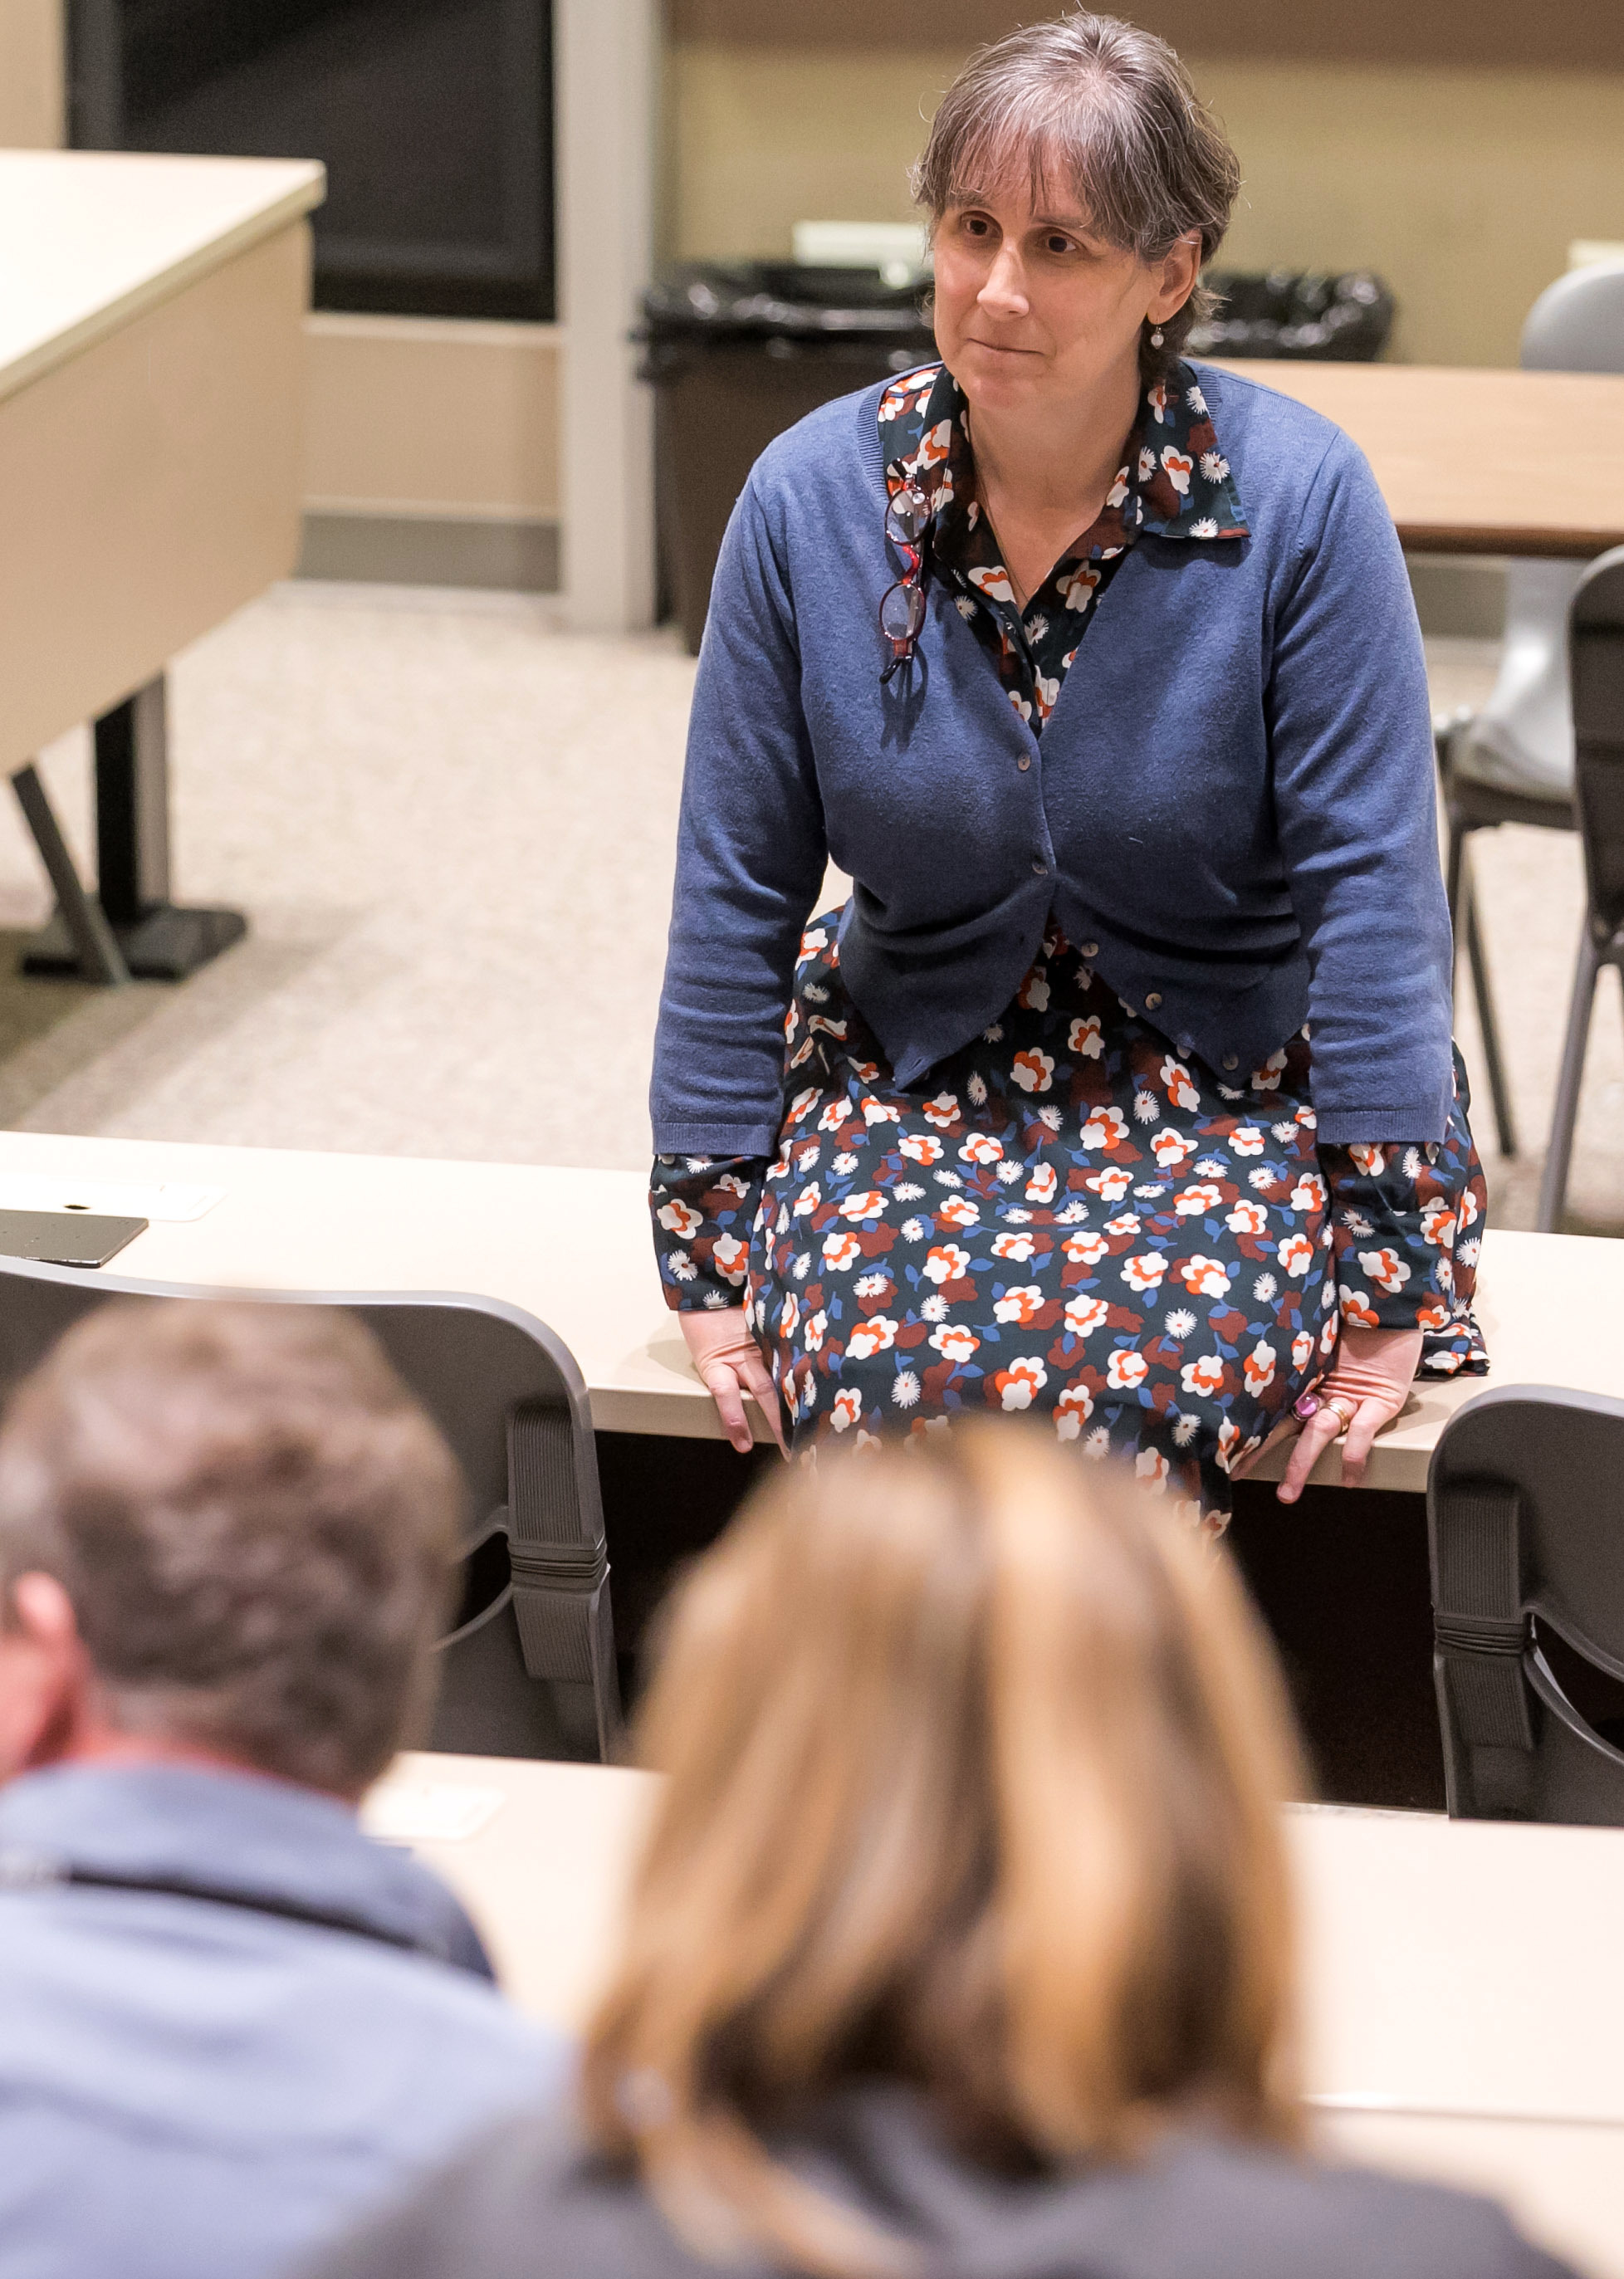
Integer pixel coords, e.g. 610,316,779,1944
879,362,1248,560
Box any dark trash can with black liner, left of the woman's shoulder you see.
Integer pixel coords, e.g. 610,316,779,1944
643,262,937,654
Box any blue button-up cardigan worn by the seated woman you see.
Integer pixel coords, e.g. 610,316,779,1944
652,364,1451,1156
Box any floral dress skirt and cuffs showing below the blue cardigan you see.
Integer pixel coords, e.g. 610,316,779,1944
656,921,1483,1524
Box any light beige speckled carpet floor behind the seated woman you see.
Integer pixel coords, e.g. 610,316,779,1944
0,584,1624,1230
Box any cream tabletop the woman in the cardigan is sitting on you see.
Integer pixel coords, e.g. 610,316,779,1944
0,1132,1624,1493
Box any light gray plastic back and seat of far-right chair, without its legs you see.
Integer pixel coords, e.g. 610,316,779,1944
1467,262,1624,798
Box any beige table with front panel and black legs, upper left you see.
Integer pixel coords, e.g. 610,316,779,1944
0,150,325,980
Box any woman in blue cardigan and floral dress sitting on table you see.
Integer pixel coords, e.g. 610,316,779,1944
652,13,1485,1518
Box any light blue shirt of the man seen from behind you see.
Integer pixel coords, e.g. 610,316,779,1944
0,1764,563,2279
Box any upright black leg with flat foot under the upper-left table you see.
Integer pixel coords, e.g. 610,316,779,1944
22,677,248,982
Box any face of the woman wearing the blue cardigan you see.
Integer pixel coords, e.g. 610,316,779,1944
932,183,1201,415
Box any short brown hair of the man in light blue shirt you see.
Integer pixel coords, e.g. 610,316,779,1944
0,1299,462,1796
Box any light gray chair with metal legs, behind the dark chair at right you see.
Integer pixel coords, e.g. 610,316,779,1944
1437,264,1624,1156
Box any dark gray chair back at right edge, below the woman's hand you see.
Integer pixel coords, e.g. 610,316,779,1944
1426,1386,1624,1827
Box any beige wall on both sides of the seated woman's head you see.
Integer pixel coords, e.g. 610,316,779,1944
665,40,1624,364
